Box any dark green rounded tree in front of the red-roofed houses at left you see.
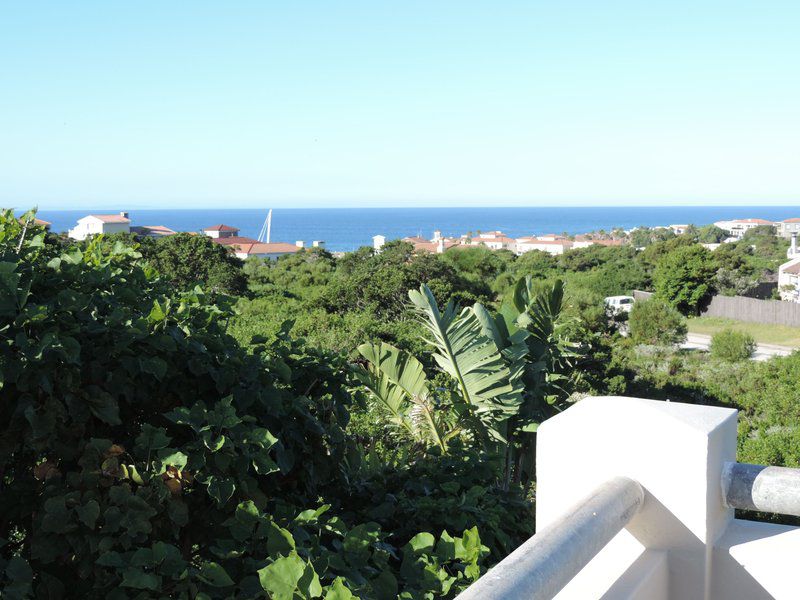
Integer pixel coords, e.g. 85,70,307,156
143,233,246,295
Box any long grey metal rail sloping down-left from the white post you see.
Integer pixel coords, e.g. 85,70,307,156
457,477,644,600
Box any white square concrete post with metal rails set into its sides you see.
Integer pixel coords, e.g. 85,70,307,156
536,397,736,600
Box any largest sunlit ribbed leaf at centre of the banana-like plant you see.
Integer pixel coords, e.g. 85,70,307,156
408,285,522,439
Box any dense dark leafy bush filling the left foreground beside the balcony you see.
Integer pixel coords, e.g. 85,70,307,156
0,213,530,600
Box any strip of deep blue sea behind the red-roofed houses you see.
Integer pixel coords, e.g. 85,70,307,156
29,206,800,251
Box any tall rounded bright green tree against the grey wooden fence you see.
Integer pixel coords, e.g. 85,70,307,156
653,245,716,314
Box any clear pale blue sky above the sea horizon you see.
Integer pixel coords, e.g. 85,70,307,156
0,0,800,209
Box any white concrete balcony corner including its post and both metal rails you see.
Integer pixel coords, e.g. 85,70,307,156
462,397,800,600
